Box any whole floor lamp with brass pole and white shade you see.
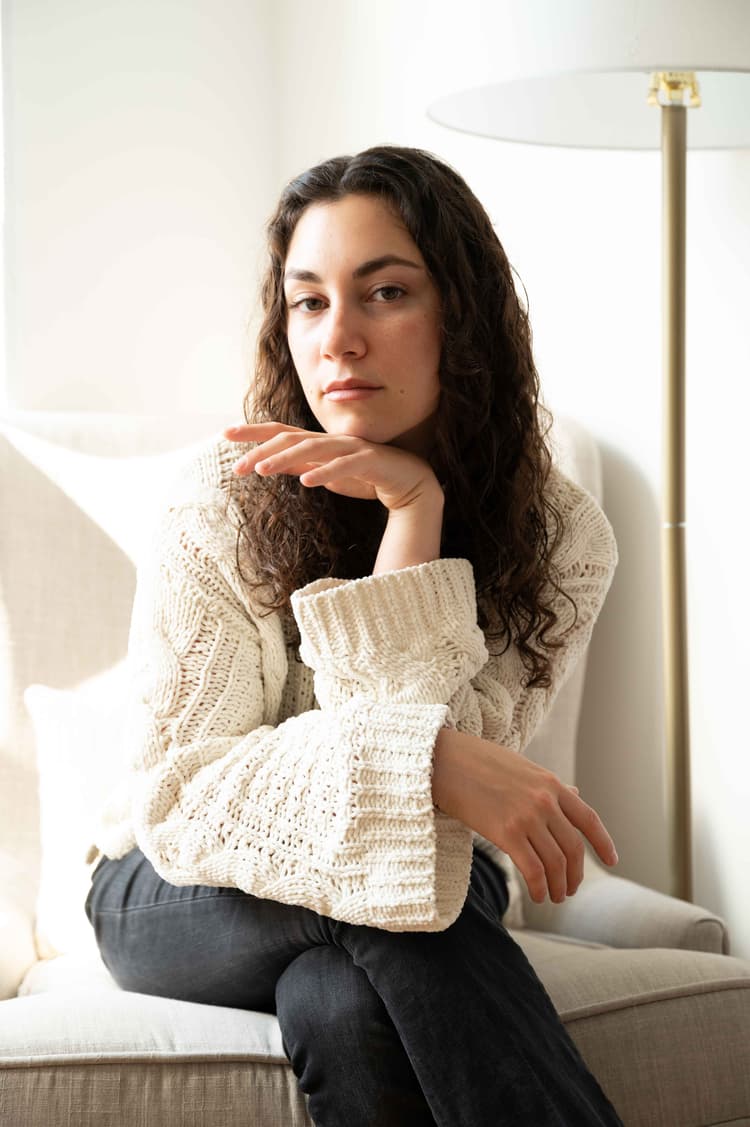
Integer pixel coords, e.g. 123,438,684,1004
427,0,750,900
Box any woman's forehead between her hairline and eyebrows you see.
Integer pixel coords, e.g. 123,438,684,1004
286,194,422,267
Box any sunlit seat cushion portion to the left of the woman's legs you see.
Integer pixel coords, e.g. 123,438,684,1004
0,956,312,1127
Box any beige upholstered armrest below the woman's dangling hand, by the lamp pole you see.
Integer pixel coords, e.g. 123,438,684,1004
523,849,730,955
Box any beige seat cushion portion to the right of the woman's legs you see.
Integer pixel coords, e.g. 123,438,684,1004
514,931,750,1127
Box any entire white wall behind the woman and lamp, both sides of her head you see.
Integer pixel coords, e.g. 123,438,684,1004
6,0,750,957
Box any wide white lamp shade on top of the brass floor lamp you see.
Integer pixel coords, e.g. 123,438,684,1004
427,0,750,149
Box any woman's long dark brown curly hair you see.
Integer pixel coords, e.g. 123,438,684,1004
231,145,577,687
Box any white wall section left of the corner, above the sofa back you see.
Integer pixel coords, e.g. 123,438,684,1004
3,0,276,415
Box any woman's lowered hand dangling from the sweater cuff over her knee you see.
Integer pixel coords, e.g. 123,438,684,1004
432,728,617,904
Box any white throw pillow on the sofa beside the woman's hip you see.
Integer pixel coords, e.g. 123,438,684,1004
24,660,130,958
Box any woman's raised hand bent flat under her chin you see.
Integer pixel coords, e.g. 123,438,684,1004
224,423,442,512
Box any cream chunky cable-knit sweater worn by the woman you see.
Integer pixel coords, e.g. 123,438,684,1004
96,438,617,931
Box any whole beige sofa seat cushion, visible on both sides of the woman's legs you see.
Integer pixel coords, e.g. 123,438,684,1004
0,931,750,1127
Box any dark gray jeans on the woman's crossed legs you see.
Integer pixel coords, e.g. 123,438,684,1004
86,850,621,1127
